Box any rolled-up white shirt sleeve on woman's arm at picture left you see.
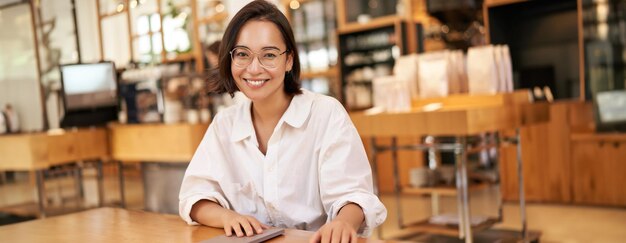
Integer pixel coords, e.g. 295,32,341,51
178,120,230,225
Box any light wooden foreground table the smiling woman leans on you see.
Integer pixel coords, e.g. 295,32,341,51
0,208,394,243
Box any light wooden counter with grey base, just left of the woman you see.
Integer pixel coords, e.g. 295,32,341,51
108,123,209,213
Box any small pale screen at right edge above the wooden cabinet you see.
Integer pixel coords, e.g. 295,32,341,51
594,90,626,132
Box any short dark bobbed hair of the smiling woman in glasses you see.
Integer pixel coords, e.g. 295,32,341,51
208,0,302,96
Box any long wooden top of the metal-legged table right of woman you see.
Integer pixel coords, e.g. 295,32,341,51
350,103,550,137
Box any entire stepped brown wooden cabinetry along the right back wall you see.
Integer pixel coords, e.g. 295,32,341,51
500,99,626,206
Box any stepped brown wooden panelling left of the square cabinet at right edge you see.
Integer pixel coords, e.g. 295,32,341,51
500,102,593,203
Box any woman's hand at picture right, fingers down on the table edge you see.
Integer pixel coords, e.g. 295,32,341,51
309,219,358,243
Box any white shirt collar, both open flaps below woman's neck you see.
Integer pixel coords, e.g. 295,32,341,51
230,89,314,142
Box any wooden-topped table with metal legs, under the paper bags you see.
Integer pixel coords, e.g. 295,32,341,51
350,91,549,243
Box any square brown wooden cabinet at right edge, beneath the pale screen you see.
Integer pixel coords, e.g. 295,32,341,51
572,134,626,206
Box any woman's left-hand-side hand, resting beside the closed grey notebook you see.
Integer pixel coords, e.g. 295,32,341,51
221,210,270,237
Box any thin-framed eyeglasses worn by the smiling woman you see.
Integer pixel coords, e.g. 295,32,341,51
230,47,289,68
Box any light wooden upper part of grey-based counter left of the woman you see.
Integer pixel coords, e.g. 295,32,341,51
109,123,209,163
